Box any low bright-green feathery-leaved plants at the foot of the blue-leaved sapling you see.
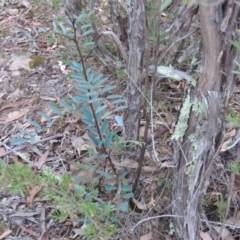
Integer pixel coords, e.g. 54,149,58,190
0,161,119,239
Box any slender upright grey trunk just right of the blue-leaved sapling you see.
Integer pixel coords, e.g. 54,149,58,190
124,0,146,140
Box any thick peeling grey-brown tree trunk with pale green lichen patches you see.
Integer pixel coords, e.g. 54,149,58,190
172,0,239,240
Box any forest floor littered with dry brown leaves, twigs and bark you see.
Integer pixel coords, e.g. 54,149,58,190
0,0,240,240
